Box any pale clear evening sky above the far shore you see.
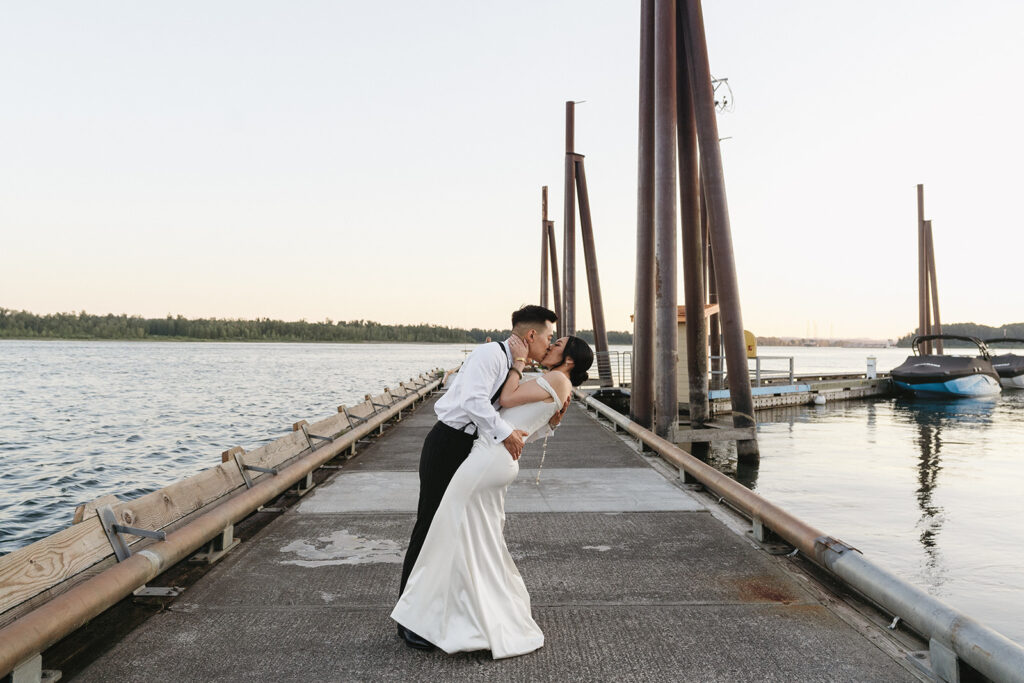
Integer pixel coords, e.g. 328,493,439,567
0,0,1024,338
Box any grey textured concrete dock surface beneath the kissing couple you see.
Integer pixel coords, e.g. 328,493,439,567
75,393,926,682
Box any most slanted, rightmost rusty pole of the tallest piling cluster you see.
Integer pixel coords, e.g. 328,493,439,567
681,0,760,463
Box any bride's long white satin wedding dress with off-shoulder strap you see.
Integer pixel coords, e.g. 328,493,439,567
391,377,560,659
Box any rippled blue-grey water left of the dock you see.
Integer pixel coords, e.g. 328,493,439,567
0,341,465,554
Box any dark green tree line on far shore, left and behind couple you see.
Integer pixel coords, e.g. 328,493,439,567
0,308,633,344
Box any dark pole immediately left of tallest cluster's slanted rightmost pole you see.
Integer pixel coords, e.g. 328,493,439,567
676,13,709,428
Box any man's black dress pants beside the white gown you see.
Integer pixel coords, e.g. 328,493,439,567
398,421,476,595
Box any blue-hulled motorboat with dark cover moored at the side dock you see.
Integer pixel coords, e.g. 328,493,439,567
891,335,1001,398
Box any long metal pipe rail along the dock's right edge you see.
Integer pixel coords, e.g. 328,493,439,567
574,389,1024,683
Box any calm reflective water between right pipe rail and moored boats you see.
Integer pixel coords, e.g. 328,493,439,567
712,392,1024,642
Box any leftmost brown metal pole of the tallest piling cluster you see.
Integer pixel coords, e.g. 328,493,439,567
630,0,654,429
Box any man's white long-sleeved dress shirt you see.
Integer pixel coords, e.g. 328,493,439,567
434,340,518,443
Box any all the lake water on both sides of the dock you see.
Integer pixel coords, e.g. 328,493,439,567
0,341,1024,642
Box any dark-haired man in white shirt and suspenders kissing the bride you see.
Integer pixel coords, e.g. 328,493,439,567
398,306,568,649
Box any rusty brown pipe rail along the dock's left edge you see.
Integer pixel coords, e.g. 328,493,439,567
0,379,441,676
